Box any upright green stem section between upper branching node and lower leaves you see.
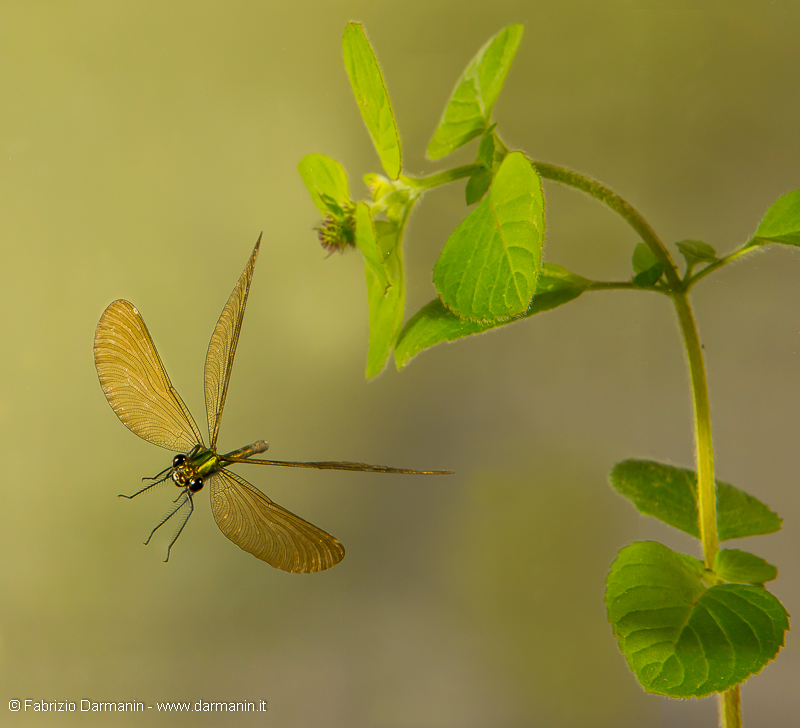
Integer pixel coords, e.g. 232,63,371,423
672,291,719,569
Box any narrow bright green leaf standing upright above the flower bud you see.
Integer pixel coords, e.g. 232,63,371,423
342,23,403,179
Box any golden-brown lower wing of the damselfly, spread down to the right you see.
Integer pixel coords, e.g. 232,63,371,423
209,470,344,574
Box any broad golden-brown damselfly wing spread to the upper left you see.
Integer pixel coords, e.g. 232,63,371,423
94,301,203,452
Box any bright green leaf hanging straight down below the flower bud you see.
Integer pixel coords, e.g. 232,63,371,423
364,220,405,379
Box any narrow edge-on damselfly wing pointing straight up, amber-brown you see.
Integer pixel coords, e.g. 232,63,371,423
205,235,261,450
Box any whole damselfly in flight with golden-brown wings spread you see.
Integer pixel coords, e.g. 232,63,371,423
94,236,451,573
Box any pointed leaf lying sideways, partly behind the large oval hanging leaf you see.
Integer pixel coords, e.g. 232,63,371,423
394,263,590,369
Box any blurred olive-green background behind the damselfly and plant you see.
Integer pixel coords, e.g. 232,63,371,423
0,0,800,728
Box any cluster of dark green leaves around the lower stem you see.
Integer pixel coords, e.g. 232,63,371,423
605,460,789,698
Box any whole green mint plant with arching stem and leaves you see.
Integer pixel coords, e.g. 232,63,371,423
299,23,800,728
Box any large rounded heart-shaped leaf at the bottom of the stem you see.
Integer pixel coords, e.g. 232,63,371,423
605,541,789,698
